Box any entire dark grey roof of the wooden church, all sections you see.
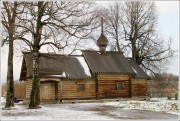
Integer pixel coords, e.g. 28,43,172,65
20,50,150,80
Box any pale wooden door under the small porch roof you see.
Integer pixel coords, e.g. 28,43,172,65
40,82,55,101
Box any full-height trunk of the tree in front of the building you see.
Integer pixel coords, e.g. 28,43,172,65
29,2,45,108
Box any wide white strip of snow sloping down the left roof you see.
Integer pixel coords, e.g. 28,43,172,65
76,57,91,76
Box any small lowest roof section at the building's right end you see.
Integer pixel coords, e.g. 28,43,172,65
127,59,150,79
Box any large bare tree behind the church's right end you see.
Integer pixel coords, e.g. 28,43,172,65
121,1,174,74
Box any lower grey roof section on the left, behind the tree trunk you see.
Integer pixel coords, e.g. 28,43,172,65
20,52,92,79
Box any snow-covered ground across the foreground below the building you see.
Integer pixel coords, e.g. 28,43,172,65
1,97,178,120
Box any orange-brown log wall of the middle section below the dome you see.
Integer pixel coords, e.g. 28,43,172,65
97,74,130,98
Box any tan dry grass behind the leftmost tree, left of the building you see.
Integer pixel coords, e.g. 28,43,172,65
1,82,26,99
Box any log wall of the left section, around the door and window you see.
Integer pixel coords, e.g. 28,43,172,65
26,79,96,102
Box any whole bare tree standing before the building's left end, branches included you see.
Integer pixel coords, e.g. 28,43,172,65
14,1,97,108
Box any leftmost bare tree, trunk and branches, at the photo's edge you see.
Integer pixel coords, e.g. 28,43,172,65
1,2,26,109
